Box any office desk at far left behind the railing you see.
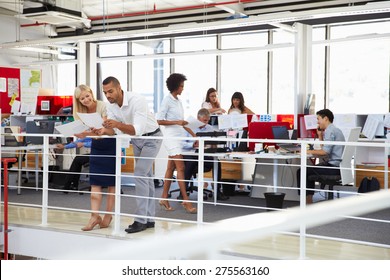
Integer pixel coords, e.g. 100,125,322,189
1,145,56,194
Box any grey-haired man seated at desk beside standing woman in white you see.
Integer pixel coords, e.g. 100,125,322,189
183,108,229,200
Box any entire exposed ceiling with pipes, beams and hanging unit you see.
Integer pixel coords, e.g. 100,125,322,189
0,0,390,59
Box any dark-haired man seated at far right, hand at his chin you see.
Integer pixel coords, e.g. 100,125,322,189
297,109,345,204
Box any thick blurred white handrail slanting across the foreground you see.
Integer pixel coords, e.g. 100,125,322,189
58,191,390,260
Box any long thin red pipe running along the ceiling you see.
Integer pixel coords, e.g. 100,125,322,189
88,0,262,21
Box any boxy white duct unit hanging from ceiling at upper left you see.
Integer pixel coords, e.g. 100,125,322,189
20,0,91,28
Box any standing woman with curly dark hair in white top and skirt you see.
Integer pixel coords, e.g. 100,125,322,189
157,73,196,213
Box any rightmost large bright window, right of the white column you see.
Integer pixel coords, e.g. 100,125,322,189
329,22,390,114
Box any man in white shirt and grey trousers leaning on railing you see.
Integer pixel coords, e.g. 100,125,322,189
100,77,162,233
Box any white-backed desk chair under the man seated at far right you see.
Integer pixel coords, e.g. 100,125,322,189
309,127,361,199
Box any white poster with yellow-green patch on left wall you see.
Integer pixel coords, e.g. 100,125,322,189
20,69,42,115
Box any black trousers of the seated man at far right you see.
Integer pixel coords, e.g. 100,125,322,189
297,163,340,195
